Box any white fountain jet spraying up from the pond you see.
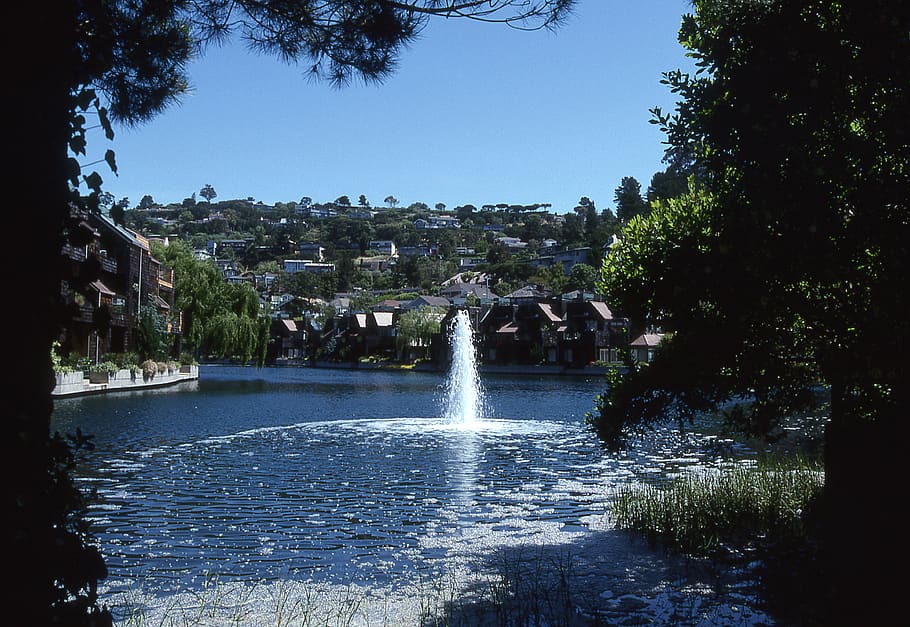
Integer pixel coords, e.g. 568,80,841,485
443,309,485,426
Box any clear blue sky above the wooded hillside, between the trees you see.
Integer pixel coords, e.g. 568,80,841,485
89,0,693,213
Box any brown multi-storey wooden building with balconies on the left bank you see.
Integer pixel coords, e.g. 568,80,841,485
58,208,183,361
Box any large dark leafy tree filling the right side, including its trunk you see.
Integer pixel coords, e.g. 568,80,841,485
598,0,910,624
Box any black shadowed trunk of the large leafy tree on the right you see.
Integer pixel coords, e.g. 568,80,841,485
821,384,910,625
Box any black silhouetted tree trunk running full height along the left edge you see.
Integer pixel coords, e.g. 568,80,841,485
0,2,105,625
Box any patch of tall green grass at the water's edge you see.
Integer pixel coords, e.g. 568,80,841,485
613,456,824,555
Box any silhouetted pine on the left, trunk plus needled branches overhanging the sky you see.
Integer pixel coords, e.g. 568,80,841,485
10,0,572,624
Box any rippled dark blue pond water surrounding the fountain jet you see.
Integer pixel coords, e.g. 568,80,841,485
54,366,767,625
